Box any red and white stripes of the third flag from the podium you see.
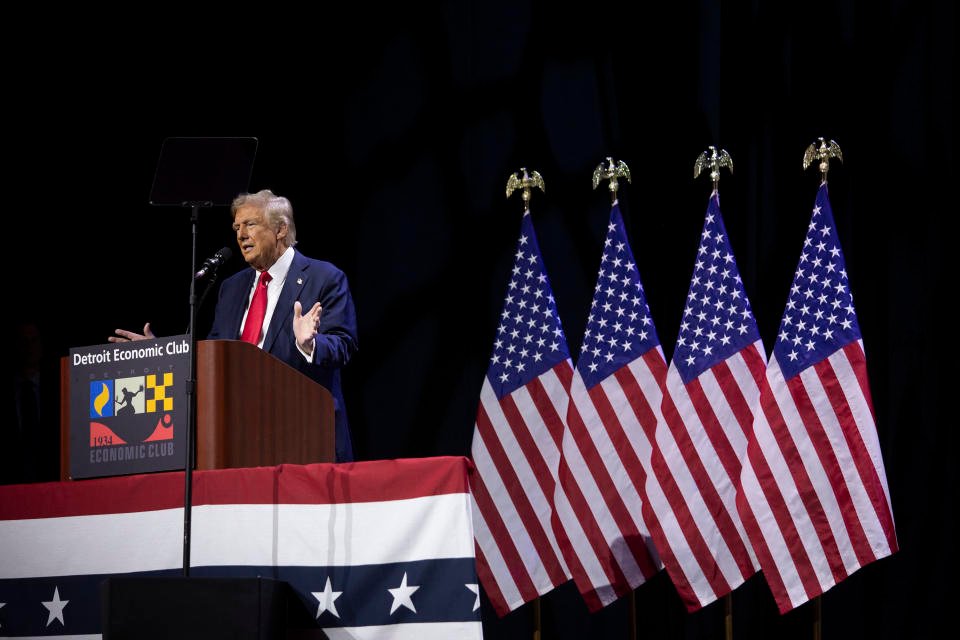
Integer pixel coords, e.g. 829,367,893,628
647,340,765,611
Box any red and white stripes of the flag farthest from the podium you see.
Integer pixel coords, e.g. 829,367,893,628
737,340,897,613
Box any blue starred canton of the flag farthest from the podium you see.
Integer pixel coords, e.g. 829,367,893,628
773,184,860,378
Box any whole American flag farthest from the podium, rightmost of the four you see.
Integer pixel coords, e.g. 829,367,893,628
737,182,897,613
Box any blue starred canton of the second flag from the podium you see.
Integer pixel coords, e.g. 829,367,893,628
577,204,660,389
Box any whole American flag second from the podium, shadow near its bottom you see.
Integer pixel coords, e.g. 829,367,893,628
555,203,666,611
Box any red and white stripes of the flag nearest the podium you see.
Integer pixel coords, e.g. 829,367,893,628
470,359,573,615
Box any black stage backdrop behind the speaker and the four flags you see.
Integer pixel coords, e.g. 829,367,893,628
2,0,957,640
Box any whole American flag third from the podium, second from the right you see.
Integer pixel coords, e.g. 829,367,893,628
647,191,765,611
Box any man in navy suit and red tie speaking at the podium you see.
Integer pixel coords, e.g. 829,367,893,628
110,189,357,462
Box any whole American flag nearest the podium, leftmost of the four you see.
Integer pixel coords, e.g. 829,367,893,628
470,212,573,615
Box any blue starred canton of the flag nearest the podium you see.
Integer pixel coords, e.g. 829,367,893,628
487,212,570,398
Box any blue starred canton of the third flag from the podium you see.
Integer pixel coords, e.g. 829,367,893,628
673,191,760,384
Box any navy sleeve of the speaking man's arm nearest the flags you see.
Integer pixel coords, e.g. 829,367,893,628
314,270,357,368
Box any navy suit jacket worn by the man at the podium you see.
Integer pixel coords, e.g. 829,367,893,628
207,251,357,462
